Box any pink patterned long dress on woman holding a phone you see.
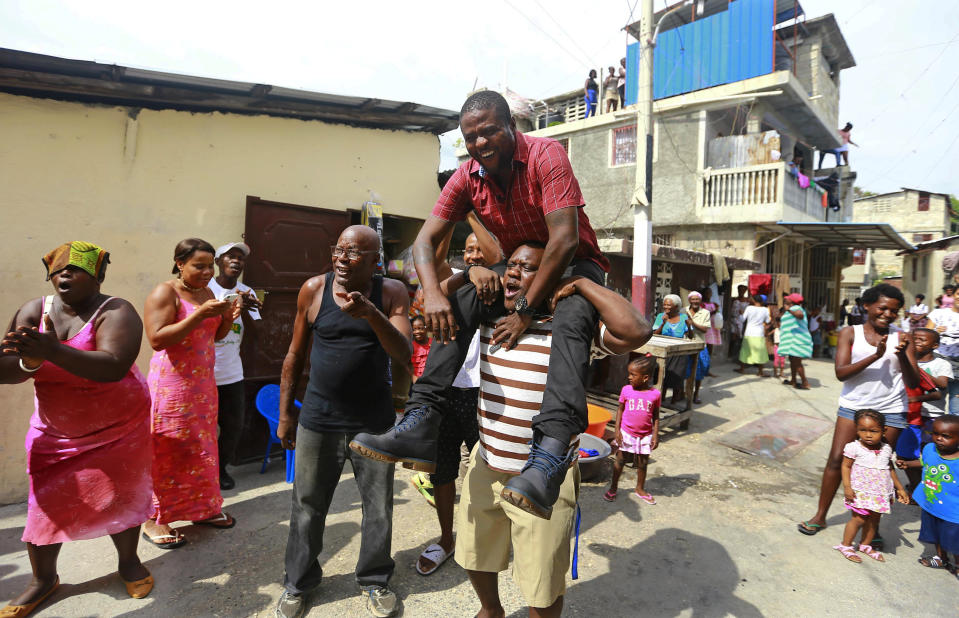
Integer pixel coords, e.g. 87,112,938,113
147,296,223,524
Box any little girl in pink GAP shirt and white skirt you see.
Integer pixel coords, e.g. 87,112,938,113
603,356,662,504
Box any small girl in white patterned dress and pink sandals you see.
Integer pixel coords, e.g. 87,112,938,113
833,410,909,562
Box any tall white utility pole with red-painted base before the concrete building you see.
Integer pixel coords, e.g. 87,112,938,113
632,0,655,316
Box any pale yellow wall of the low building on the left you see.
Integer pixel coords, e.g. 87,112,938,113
0,93,439,503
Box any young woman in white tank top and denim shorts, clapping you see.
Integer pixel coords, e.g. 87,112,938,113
799,283,919,546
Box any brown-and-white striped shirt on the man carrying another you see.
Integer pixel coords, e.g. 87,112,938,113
476,321,609,474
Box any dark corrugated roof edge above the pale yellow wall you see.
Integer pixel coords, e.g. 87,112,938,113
0,48,459,134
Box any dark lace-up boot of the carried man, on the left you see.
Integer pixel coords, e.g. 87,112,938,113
350,406,443,473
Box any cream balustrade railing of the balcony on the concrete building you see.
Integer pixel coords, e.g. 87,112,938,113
699,162,827,223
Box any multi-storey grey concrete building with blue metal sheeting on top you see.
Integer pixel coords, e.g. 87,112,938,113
516,6,911,318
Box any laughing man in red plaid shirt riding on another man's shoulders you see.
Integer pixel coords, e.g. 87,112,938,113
350,91,609,518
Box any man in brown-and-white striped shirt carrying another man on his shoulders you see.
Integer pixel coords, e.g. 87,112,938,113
444,242,651,616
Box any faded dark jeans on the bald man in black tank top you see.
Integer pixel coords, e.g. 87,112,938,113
283,425,395,595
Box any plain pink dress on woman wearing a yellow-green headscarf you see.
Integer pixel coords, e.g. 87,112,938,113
22,299,152,545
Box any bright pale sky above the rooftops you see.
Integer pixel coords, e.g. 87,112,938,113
0,0,959,195
